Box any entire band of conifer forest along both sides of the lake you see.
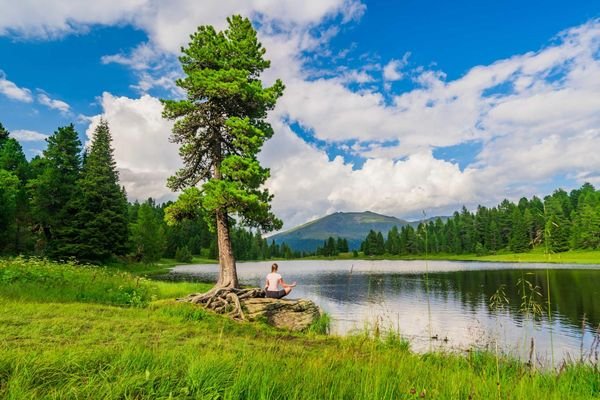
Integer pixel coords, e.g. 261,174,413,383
0,121,600,263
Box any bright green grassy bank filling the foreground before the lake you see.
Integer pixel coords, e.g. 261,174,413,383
0,260,600,399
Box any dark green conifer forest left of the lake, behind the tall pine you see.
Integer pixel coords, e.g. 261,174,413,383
0,121,292,263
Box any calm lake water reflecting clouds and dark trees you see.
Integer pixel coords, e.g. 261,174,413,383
172,260,600,365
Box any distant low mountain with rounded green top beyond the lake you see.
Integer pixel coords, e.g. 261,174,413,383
267,211,410,251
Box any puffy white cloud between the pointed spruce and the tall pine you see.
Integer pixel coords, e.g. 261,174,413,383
86,93,181,201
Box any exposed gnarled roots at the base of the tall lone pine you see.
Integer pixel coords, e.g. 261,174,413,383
177,288,265,321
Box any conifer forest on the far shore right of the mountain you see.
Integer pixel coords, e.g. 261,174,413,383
361,183,600,256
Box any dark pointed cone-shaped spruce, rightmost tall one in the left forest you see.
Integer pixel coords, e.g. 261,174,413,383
65,121,128,261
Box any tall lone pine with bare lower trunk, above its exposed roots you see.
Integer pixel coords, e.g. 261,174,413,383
163,16,284,288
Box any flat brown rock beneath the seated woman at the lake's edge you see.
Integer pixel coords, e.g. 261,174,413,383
241,298,321,331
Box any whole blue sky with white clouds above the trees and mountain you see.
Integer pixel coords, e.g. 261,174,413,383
0,0,600,229
